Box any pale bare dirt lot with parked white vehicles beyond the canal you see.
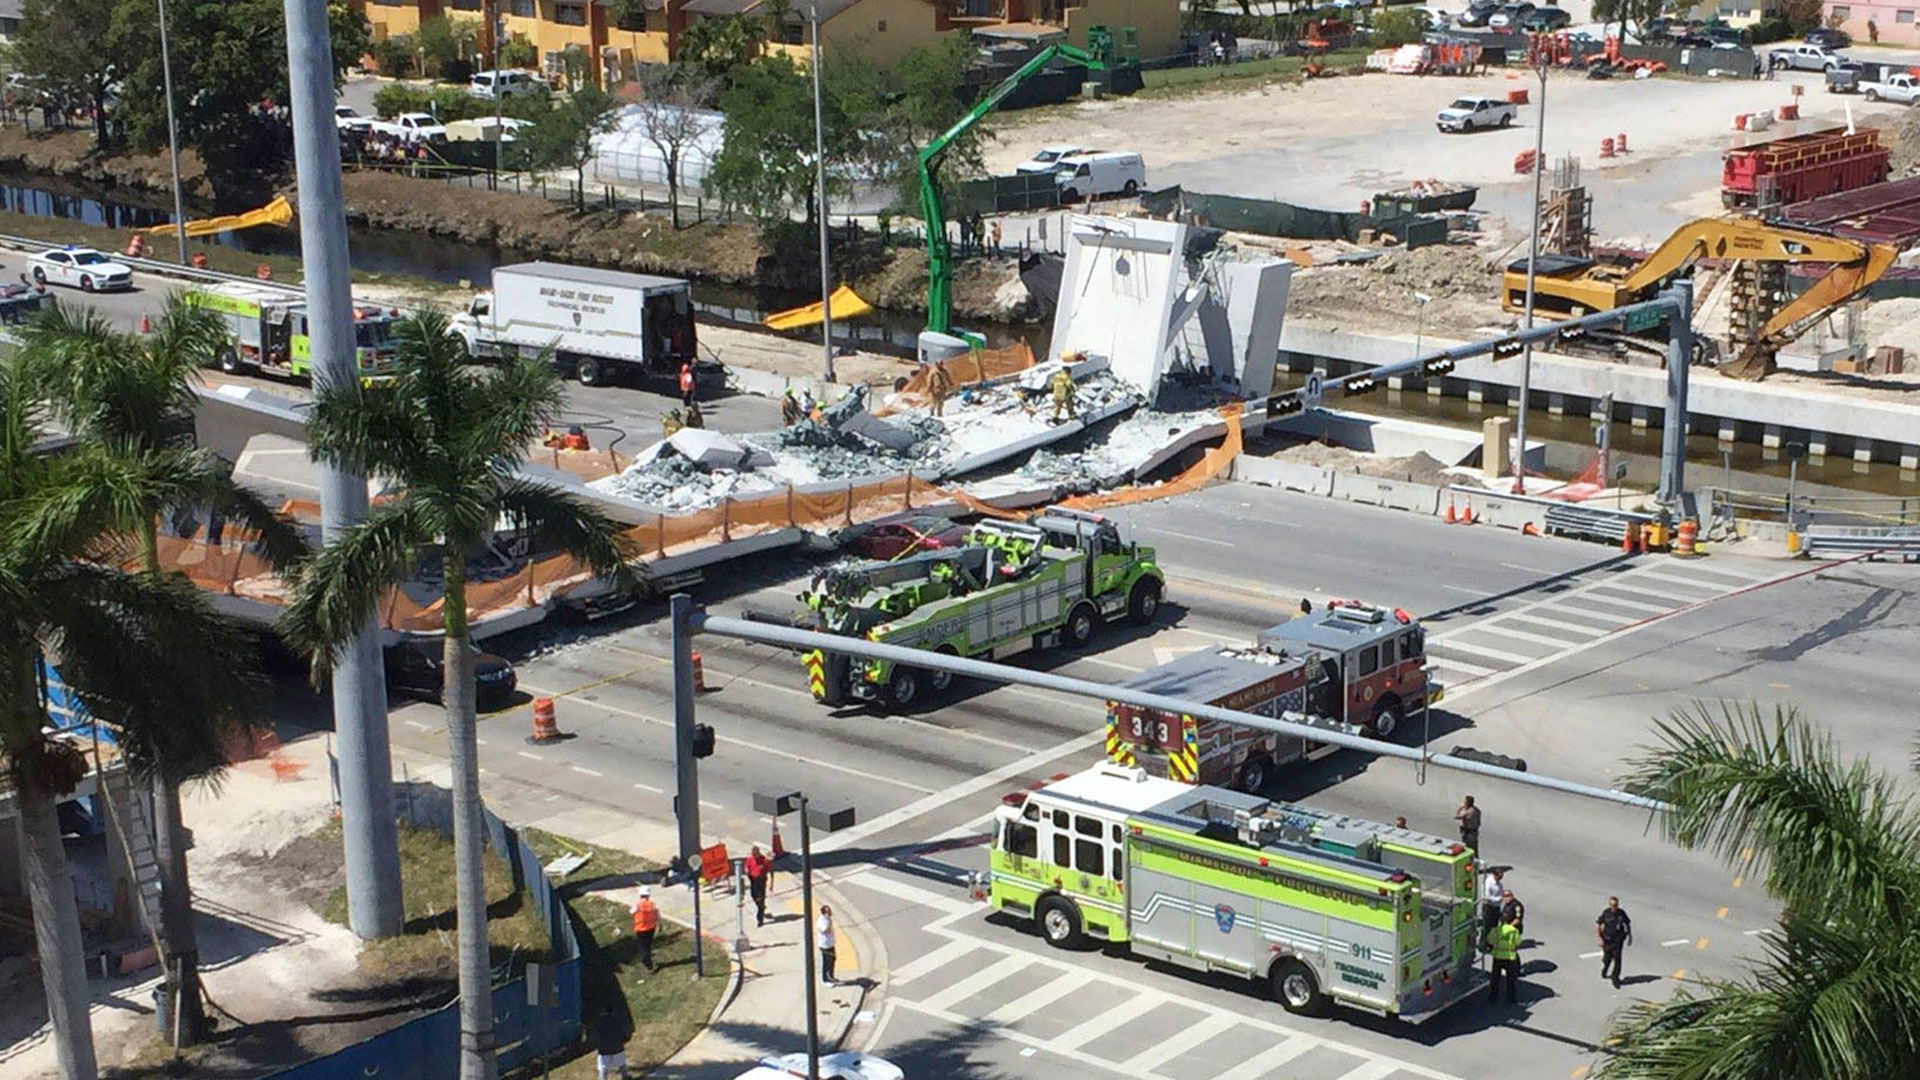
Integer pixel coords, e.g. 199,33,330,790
987,71,1907,242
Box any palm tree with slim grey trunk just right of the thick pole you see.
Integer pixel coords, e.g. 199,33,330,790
284,315,632,1080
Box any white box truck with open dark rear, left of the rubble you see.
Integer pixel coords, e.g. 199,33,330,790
449,263,724,388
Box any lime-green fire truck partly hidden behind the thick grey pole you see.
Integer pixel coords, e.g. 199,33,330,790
186,281,397,382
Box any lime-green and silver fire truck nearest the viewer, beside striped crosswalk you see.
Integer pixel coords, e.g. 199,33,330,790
987,761,1484,1022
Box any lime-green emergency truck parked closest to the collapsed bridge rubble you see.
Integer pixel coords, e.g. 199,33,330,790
801,507,1165,709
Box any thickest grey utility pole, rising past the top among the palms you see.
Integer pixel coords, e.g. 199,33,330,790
284,0,403,938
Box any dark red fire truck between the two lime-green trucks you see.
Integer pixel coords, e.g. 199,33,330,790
1106,600,1444,792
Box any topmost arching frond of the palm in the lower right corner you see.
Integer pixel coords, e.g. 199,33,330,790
1624,703,1920,919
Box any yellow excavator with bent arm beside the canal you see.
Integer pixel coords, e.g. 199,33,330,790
1500,217,1899,380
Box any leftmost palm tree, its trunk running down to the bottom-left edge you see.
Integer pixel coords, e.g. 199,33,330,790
0,356,272,1080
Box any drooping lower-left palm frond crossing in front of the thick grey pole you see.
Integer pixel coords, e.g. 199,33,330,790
280,502,422,669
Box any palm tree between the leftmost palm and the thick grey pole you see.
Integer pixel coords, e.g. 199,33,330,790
21,294,305,1045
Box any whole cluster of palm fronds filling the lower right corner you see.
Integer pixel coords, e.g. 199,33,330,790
1596,703,1920,1080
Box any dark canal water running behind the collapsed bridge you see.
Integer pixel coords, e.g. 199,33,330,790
0,177,1920,496
